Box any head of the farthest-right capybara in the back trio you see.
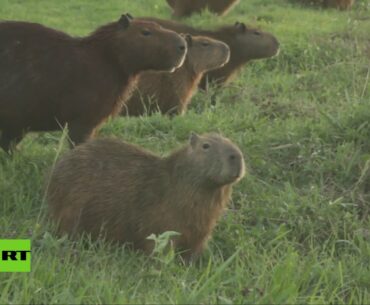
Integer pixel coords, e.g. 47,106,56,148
229,22,279,60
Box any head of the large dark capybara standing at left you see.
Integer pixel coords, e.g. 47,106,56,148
109,14,187,72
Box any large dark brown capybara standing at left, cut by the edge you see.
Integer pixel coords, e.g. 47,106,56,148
0,14,187,151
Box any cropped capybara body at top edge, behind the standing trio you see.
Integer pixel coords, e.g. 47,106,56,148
167,0,239,17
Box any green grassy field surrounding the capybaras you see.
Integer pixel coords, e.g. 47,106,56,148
0,0,370,304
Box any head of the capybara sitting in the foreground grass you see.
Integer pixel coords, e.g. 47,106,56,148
184,133,245,187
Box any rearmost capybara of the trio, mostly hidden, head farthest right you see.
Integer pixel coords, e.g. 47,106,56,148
140,17,279,89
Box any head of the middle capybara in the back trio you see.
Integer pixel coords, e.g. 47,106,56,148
185,34,230,74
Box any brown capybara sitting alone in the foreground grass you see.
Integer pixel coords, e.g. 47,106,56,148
47,133,245,259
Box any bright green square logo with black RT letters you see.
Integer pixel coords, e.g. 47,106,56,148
0,239,31,272
